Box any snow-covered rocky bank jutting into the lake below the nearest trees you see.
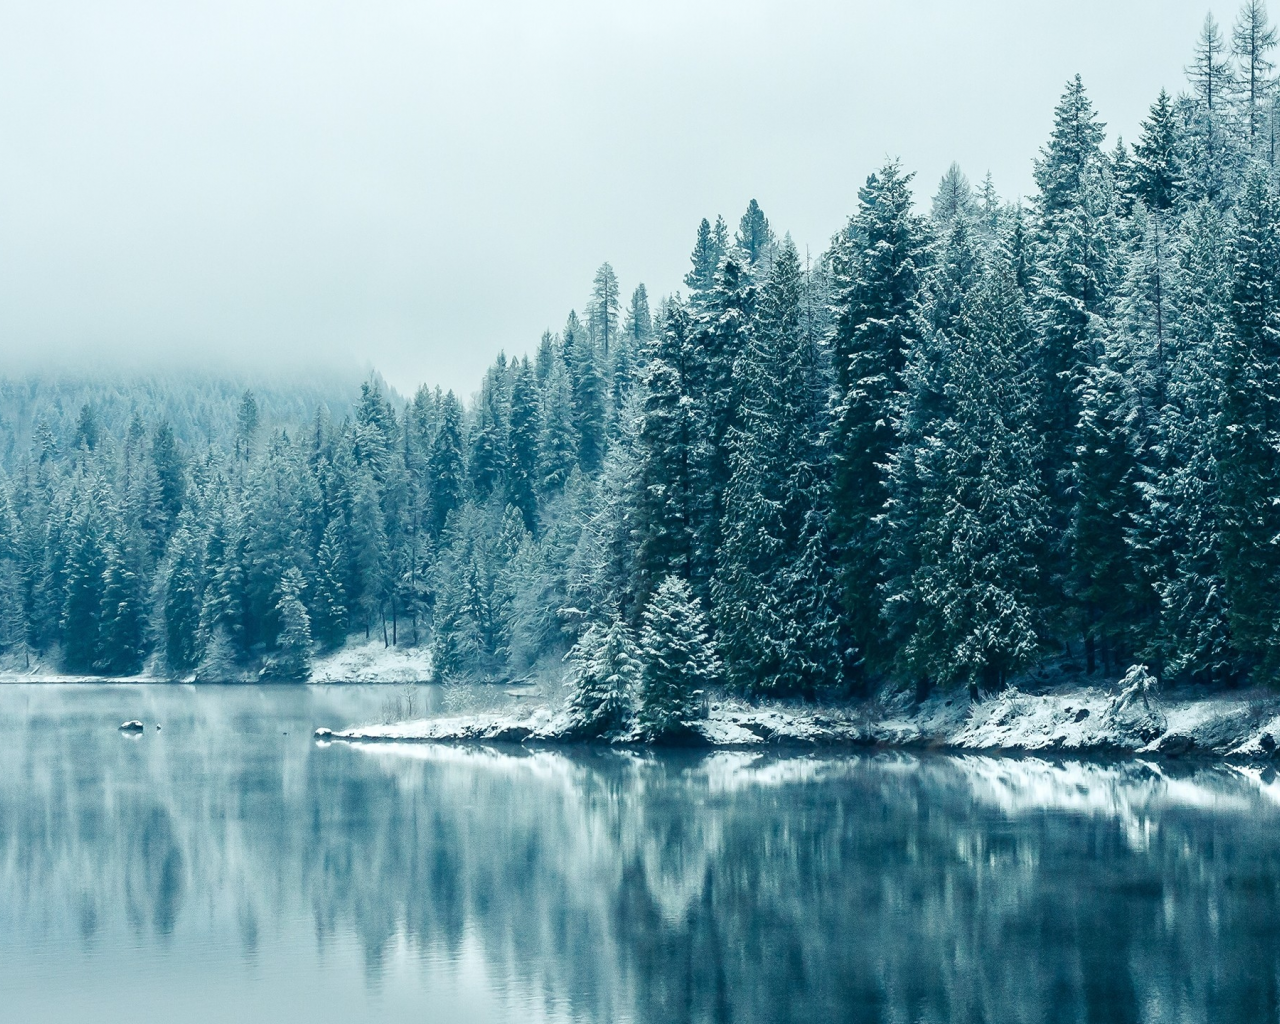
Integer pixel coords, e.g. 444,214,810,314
320,681,1280,762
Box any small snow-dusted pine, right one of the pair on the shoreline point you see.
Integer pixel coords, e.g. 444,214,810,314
636,576,721,741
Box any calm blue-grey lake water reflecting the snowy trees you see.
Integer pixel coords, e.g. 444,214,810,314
0,686,1280,1024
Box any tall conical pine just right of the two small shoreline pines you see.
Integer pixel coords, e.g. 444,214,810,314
712,238,841,695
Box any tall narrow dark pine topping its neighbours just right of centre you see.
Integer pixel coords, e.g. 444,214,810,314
832,163,925,668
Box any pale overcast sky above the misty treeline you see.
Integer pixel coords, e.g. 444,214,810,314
0,0,1249,393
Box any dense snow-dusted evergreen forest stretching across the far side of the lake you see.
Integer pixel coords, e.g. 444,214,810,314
0,8,1280,716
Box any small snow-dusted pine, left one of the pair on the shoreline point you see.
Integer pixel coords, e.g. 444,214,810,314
566,618,640,740
